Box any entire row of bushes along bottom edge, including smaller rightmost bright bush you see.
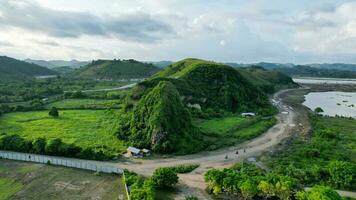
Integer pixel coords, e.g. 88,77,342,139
204,162,346,200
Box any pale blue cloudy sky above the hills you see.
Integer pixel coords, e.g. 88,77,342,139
0,0,356,64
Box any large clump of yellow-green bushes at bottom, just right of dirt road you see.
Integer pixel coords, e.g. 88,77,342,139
205,162,297,199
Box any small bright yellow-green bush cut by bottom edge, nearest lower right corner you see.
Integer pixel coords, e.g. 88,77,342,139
296,186,342,200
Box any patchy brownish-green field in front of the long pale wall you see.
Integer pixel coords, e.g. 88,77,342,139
0,159,126,200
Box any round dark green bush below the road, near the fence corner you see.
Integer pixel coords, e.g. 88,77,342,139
152,168,178,188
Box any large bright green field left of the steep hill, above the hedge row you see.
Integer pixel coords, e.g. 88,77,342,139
0,110,126,153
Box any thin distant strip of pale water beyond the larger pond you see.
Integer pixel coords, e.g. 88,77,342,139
293,77,356,85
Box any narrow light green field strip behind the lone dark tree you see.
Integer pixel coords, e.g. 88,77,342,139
46,99,120,109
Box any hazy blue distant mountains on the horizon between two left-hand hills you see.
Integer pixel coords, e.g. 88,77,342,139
24,59,90,69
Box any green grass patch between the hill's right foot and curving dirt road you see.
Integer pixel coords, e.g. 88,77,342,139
194,116,276,150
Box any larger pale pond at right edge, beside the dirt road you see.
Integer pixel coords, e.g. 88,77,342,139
303,92,356,118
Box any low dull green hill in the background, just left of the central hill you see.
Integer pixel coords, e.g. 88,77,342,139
72,60,159,80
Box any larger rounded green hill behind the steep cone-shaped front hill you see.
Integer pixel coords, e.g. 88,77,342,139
139,59,269,112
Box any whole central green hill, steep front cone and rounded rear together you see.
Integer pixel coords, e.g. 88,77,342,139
118,59,286,153
